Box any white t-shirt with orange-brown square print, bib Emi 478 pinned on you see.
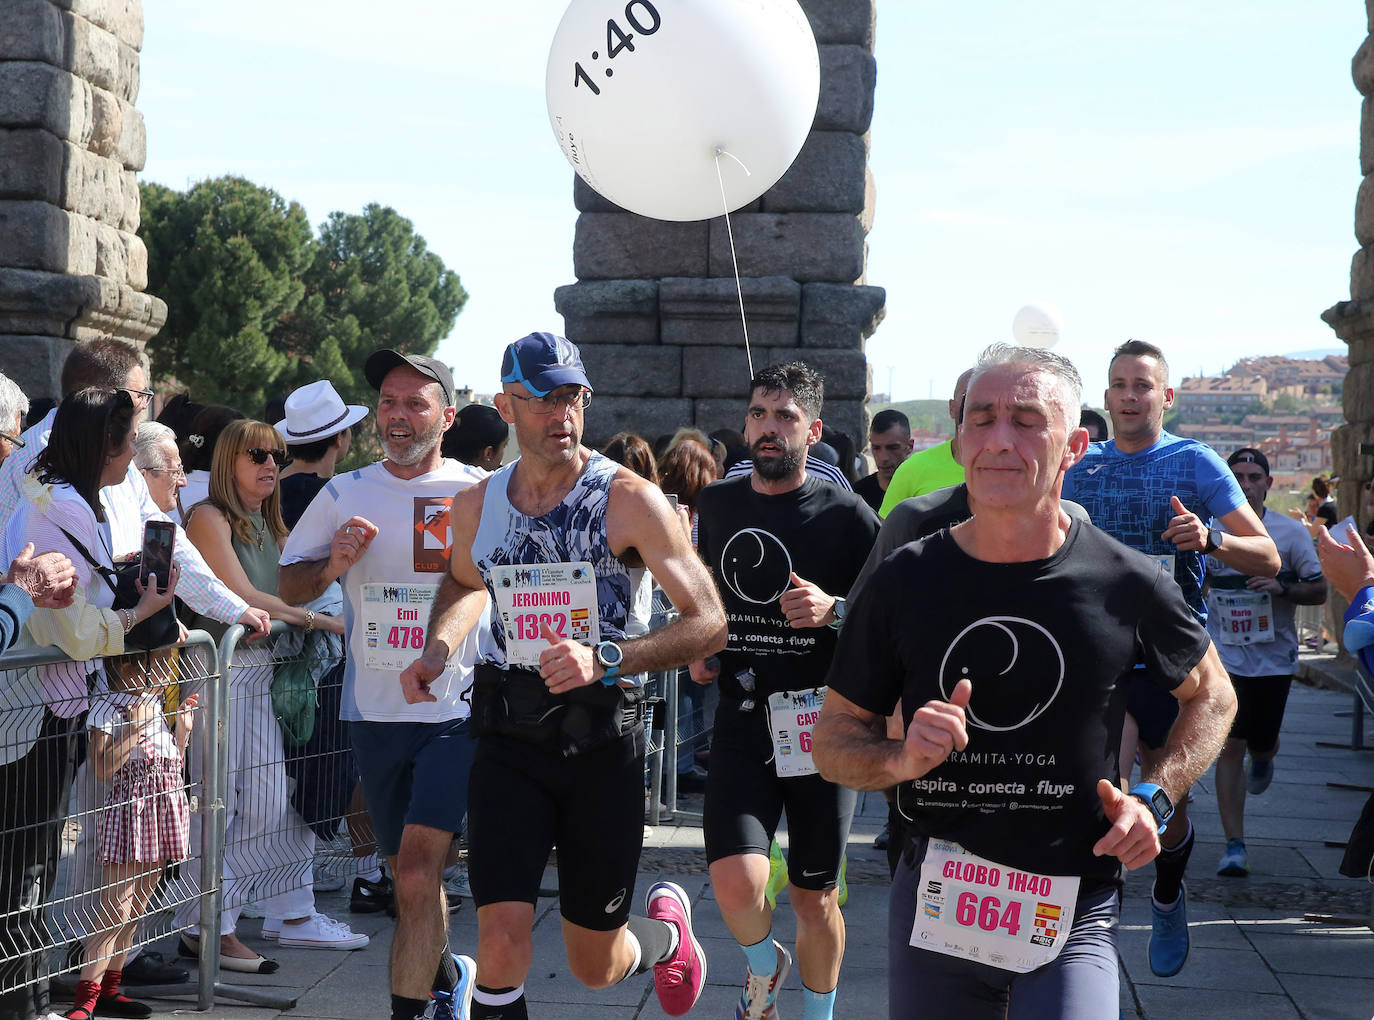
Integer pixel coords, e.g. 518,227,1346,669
282,461,486,723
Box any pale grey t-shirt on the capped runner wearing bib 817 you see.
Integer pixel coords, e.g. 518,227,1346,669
1206,507,1322,676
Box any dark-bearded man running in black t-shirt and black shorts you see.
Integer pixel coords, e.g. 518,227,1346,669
698,363,878,1020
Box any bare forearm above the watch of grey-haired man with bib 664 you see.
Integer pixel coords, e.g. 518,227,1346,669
1140,642,1235,803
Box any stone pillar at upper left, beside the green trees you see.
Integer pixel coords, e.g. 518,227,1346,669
0,0,166,397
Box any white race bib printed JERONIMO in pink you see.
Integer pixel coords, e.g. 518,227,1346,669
492,562,600,668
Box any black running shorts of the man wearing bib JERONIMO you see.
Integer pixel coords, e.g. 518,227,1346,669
467,727,644,932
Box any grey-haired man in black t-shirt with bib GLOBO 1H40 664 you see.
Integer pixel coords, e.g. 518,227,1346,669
815,345,1235,1017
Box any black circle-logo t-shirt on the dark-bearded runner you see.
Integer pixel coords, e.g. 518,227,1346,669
697,474,879,700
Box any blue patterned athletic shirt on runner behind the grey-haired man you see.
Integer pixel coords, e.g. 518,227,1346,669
1063,432,1245,623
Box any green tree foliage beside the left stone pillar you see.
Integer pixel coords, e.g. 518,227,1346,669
142,177,467,415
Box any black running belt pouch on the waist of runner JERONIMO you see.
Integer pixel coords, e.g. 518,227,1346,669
471,664,643,757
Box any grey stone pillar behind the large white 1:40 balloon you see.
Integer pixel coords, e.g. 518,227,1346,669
554,0,885,445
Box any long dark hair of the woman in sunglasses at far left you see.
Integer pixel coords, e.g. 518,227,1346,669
33,386,133,510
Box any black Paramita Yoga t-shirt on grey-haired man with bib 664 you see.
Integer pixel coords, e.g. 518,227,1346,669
829,521,1208,880
